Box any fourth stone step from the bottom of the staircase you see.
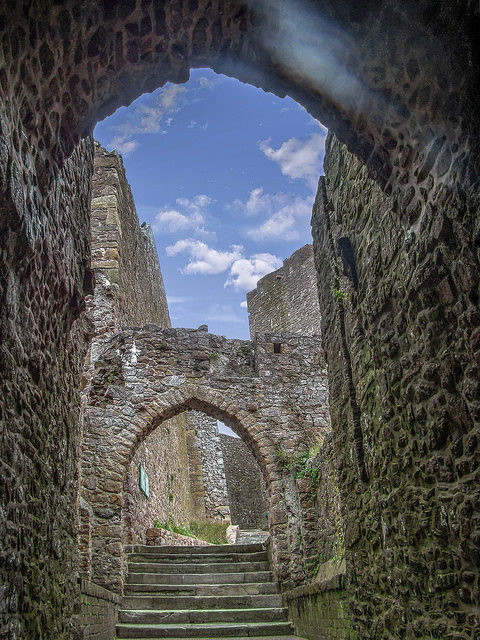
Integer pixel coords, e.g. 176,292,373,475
124,584,279,597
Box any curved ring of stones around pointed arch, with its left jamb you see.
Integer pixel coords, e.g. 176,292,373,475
82,388,279,593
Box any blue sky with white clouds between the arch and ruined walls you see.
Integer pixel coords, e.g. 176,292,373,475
94,69,326,338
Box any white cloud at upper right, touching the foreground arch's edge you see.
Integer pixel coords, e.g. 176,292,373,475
259,127,326,189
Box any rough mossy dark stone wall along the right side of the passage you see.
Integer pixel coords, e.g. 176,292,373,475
312,136,480,640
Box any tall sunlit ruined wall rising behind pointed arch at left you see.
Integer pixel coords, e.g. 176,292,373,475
86,142,171,360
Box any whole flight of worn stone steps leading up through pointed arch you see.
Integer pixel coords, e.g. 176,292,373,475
117,544,299,640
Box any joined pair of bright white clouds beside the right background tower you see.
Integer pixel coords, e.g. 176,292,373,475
166,238,282,291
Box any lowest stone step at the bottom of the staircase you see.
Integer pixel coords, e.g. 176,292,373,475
117,622,293,640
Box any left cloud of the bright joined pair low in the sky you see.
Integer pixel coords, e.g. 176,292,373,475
166,238,243,275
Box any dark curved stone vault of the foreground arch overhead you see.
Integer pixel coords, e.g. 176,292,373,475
2,0,478,207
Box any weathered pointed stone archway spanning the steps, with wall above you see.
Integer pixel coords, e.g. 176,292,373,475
81,325,329,592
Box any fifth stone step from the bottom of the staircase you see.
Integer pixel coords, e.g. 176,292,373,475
127,571,273,585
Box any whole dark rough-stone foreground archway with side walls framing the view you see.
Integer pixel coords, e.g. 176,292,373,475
0,0,480,640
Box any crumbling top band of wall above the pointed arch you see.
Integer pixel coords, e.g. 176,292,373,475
92,324,326,390
